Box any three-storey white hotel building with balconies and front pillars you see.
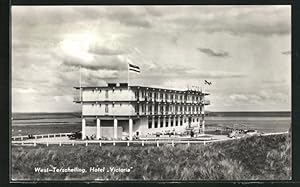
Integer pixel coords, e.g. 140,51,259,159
74,83,209,140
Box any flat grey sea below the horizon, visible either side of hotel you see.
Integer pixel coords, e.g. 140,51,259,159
11,112,291,136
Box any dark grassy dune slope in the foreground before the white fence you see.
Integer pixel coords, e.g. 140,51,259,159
12,135,291,180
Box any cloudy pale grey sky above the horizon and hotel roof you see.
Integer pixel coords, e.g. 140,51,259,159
11,5,291,112
